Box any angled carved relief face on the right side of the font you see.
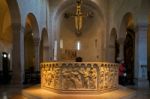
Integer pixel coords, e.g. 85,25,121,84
99,64,118,90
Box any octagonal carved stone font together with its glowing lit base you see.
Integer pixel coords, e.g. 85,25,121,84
22,62,136,99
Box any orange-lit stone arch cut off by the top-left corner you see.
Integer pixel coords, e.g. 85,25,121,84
0,0,21,48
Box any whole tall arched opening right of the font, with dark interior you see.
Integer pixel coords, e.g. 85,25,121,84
120,12,135,84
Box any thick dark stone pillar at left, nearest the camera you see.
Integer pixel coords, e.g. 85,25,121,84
11,25,24,86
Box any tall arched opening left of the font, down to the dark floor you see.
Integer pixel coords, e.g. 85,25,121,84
24,13,40,84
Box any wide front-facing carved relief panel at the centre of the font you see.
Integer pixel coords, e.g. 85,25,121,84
62,64,97,90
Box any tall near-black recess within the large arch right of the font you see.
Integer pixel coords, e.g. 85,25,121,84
124,28,135,84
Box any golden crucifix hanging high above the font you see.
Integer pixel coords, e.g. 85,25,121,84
65,0,93,36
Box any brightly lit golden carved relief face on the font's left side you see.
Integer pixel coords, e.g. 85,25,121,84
41,64,61,89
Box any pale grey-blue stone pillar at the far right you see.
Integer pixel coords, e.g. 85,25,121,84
134,24,149,88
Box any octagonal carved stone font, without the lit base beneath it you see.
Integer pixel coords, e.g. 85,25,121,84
41,62,118,93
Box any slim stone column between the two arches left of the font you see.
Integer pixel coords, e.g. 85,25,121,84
34,38,40,71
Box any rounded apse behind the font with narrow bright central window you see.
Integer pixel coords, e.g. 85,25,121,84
56,1,105,61
